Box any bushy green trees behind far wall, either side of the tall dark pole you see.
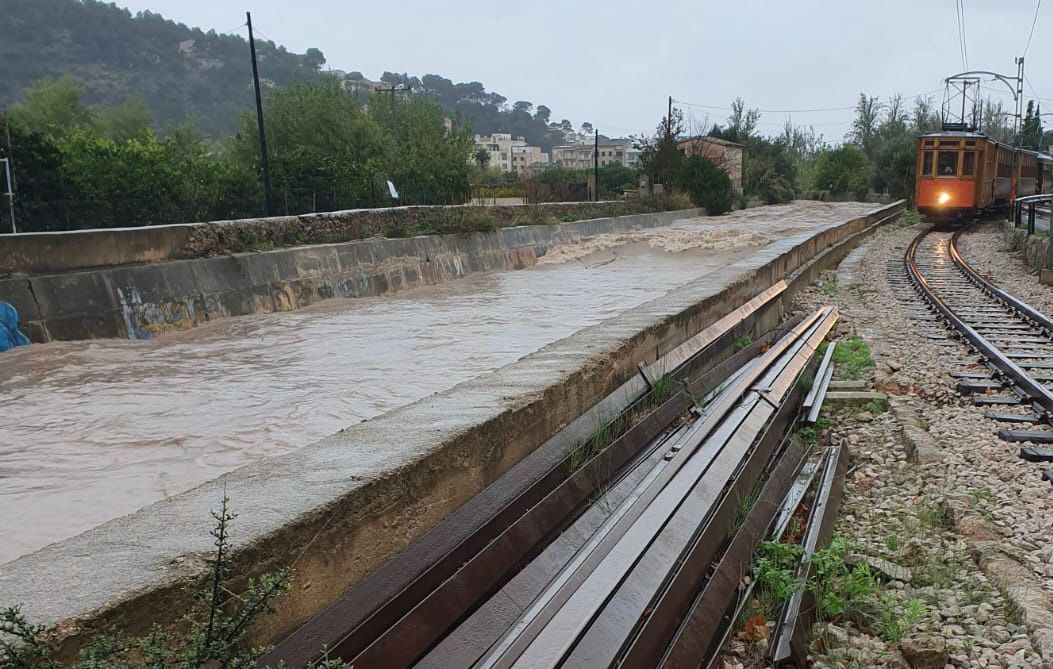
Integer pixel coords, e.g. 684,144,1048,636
0,77,473,231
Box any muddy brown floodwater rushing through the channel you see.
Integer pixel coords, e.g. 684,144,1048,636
0,202,874,563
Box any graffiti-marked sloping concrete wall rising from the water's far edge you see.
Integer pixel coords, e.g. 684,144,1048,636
0,208,699,342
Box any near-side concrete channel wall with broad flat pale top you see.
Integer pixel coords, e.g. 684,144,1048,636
0,202,902,652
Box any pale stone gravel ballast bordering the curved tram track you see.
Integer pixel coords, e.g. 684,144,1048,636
741,223,1053,668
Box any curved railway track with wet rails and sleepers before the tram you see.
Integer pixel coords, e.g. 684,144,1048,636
893,225,1053,465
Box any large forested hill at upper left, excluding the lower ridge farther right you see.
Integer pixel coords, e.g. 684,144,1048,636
0,0,325,135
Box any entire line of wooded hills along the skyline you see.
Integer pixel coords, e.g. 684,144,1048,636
0,0,588,151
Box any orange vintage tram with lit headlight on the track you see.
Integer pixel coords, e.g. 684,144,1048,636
914,131,1053,221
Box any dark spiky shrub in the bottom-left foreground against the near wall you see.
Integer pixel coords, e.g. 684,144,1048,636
0,497,351,669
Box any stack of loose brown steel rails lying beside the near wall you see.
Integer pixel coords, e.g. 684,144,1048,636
263,299,848,669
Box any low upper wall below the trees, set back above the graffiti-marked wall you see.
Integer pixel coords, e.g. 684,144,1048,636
0,200,643,277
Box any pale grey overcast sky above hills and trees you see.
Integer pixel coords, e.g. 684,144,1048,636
118,0,1053,140
